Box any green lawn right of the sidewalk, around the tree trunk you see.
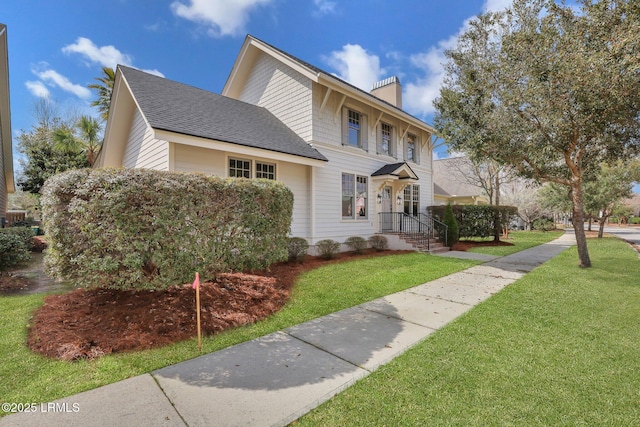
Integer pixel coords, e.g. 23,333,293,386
296,238,640,426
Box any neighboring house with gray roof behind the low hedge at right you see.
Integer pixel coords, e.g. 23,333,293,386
433,157,489,205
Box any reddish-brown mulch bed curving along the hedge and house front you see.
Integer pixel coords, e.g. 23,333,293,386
27,251,407,360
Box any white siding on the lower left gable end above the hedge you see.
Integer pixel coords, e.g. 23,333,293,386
122,109,169,171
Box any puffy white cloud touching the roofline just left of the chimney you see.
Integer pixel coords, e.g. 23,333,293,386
326,44,385,91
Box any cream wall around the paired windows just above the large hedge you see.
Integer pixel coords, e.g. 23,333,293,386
173,144,311,238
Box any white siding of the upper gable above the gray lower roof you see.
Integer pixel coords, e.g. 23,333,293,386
238,55,312,141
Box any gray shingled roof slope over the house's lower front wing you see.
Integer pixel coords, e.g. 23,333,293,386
118,65,327,161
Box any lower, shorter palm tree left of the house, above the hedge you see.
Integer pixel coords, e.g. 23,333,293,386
53,116,102,166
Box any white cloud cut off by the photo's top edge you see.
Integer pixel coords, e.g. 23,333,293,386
171,0,273,37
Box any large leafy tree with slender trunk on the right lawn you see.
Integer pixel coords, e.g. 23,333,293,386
434,0,640,267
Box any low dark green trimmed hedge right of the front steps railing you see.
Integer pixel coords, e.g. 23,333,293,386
427,205,518,244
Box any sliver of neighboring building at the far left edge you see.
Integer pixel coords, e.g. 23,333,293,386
0,24,15,227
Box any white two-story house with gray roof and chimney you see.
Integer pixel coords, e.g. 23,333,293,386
96,36,434,252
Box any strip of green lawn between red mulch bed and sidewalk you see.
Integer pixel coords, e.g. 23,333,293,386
0,253,476,415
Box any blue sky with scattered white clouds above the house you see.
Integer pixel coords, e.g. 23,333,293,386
0,0,511,174
